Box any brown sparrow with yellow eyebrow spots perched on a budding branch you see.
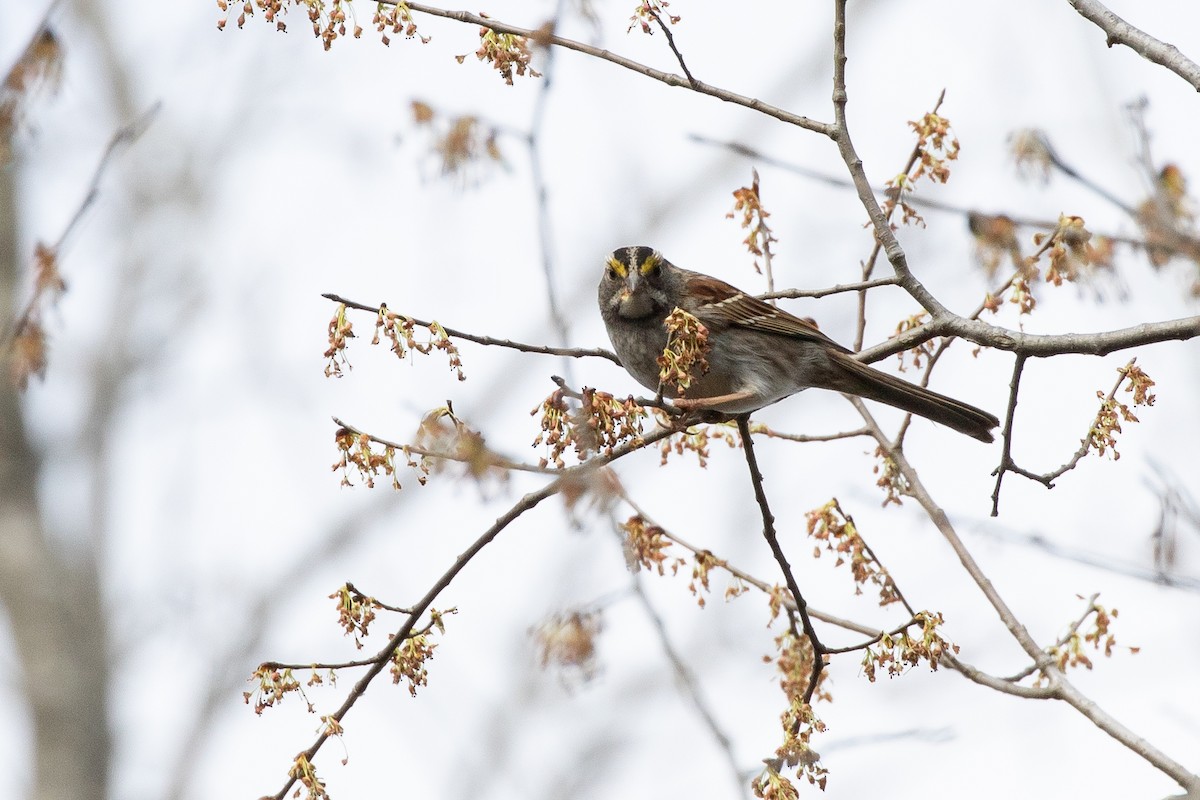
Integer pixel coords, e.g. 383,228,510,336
598,246,1000,441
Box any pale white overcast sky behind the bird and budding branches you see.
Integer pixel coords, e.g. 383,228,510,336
0,0,1200,800
